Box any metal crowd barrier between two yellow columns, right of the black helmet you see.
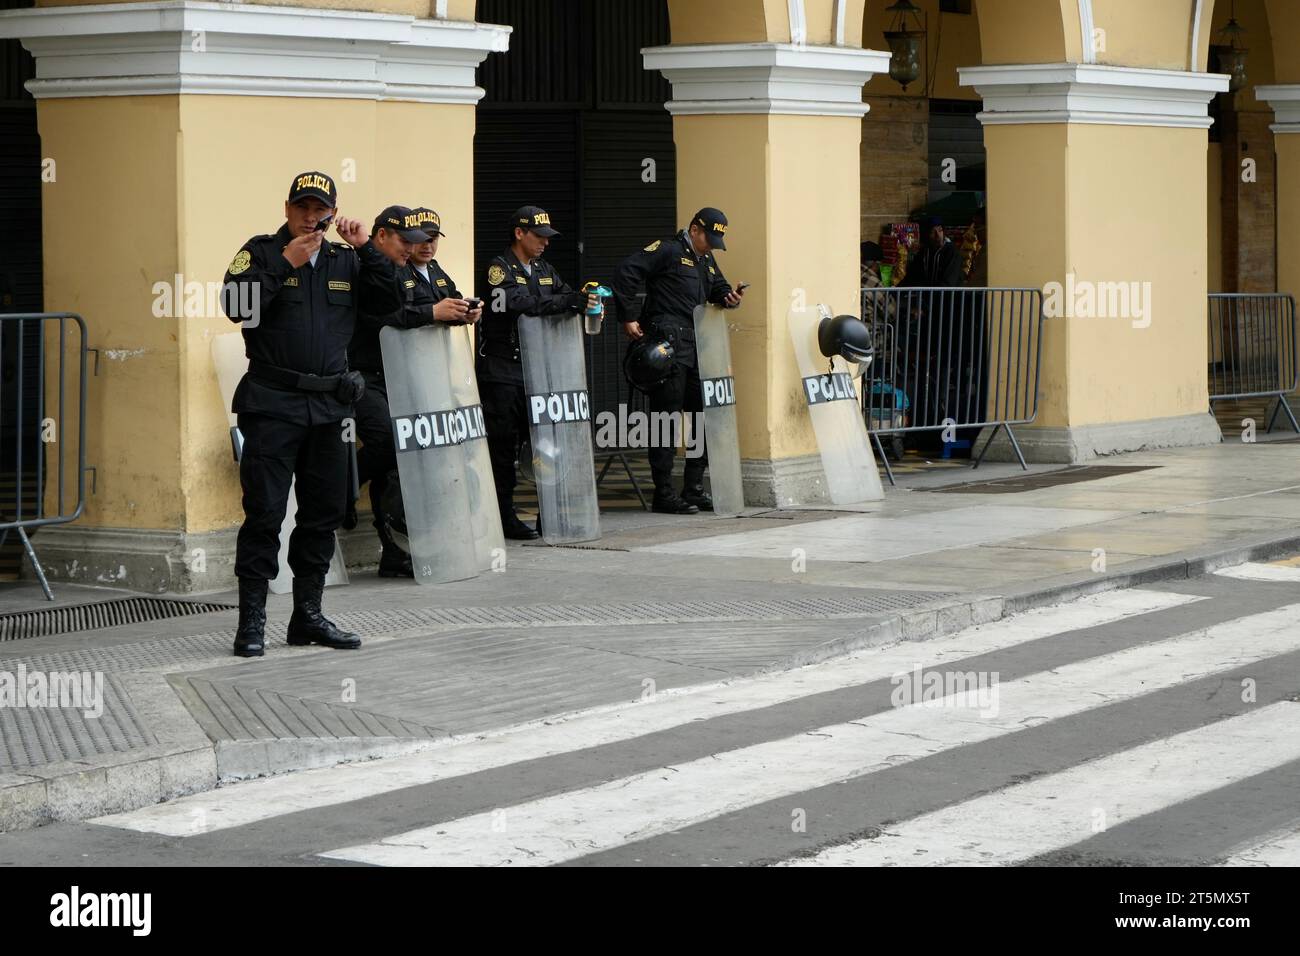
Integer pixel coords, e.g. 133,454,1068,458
862,287,1043,484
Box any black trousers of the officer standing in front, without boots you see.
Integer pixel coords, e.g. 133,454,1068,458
235,414,347,580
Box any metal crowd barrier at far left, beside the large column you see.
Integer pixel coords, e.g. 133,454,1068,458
0,312,87,601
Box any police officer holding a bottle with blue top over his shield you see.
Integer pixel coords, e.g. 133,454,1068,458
476,206,601,541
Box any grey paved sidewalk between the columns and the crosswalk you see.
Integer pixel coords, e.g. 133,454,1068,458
0,441,1300,829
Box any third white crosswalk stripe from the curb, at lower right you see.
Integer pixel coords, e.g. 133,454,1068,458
787,701,1300,866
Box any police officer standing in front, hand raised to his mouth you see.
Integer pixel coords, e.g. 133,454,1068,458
222,172,402,657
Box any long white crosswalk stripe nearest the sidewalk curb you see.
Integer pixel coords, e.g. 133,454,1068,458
94,591,1206,836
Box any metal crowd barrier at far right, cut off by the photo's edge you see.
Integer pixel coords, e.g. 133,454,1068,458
1209,293,1300,432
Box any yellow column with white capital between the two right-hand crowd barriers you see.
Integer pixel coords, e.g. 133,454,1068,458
961,64,1227,463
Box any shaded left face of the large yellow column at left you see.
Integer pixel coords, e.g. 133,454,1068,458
36,96,184,528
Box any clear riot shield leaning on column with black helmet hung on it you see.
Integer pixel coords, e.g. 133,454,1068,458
785,306,885,505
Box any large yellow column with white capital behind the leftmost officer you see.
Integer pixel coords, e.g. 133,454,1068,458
0,3,508,592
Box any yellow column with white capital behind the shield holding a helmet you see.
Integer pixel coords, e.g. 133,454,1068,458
645,42,888,505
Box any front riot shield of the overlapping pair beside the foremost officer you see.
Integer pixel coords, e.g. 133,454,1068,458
380,324,486,584
